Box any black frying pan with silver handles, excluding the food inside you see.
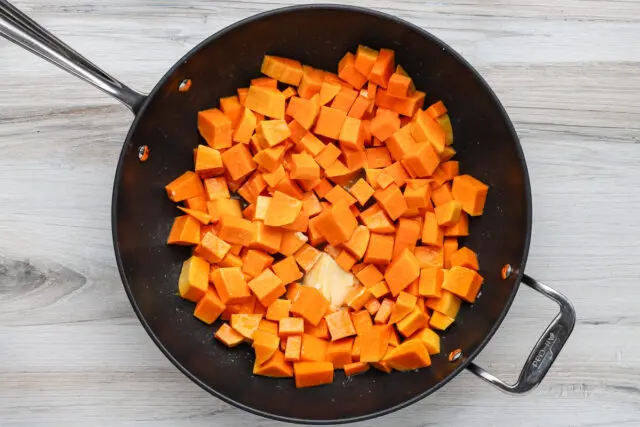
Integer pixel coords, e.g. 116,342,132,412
0,0,575,424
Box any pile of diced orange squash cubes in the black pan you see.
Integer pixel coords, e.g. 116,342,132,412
166,46,488,387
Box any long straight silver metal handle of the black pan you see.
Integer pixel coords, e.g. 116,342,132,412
0,0,146,114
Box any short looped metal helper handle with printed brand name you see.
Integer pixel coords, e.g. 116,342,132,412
468,274,576,394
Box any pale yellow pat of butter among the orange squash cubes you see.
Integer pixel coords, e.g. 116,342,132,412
303,252,357,309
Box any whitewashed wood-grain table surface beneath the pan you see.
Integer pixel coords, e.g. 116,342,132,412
0,0,640,427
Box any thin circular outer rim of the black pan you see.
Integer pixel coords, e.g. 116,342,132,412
111,4,533,425
